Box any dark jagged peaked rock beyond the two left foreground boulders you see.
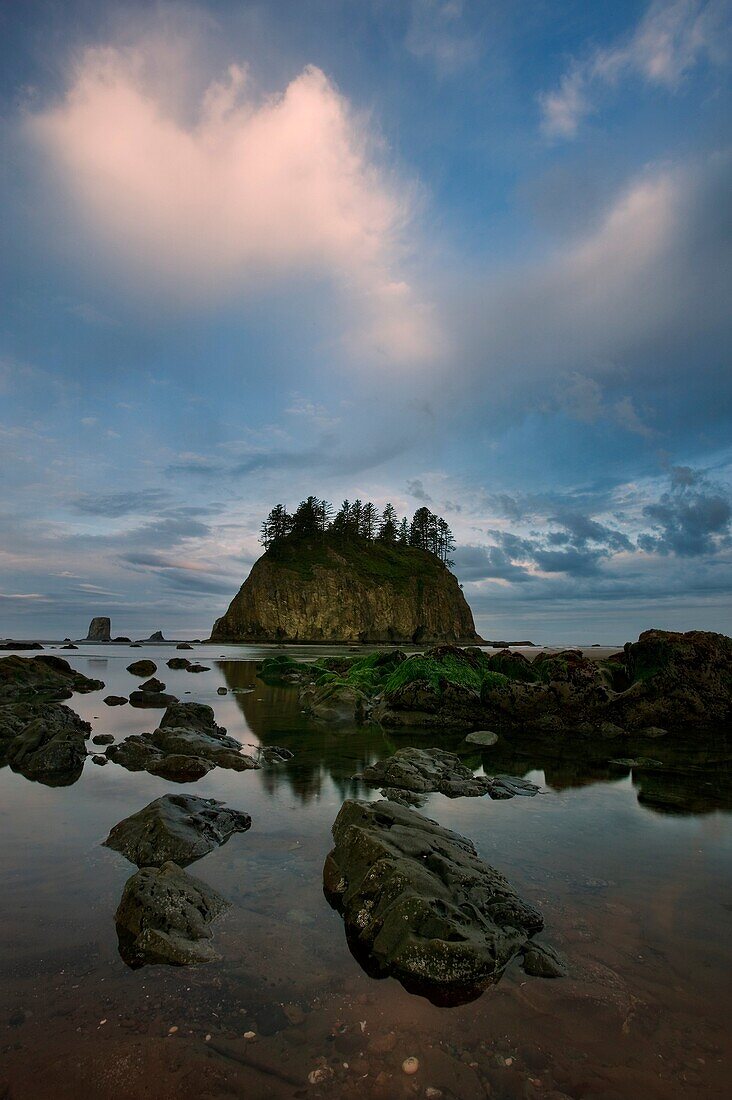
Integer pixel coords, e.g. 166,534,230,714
107,695,260,783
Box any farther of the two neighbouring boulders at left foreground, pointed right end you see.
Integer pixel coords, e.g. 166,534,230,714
105,794,252,867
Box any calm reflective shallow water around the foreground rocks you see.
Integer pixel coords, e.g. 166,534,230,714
0,646,732,1100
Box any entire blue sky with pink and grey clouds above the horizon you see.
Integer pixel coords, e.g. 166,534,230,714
0,0,732,644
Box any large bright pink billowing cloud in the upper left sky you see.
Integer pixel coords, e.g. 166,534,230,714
28,44,436,361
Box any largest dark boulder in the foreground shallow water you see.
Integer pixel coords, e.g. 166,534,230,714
324,800,544,1003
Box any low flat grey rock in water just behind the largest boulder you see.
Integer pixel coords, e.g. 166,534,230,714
362,748,538,799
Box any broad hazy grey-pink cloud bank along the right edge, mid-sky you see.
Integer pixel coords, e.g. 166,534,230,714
452,154,732,442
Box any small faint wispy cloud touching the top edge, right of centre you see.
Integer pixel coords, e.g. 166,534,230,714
405,0,480,76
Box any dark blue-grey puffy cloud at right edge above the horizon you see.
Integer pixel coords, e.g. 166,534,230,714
638,466,732,558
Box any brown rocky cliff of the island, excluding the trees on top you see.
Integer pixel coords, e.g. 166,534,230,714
211,539,479,645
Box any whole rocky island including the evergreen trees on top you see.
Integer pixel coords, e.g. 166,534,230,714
211,497,480,645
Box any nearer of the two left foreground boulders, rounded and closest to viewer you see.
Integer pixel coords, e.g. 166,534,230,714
116,862,229,967
